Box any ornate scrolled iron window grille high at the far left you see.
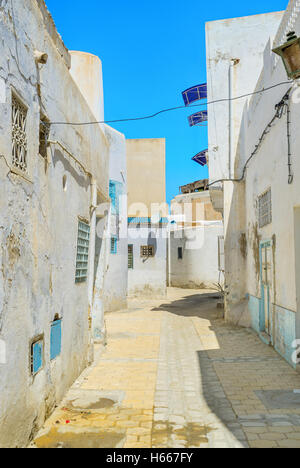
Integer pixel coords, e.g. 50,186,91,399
12,95,27,172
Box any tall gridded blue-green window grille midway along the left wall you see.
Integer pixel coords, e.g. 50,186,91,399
75,221,90,283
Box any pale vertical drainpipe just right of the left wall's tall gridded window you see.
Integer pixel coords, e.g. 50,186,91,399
88,177,97,328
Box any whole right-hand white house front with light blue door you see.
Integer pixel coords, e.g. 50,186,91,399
207,1,300,367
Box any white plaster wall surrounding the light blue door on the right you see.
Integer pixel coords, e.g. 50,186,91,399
242,8,300,311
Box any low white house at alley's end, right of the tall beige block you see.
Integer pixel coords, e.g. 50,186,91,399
168,184,224,289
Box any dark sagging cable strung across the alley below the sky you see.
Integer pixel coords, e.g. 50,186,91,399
48,81,292,126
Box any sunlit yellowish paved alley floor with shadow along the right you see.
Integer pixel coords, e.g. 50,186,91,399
32,289,300,448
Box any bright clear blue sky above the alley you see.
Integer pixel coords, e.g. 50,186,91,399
46,0,288,202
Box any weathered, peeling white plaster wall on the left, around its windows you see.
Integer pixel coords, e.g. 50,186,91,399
0,0,109,447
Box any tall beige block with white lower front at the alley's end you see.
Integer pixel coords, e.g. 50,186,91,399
126,138,168,296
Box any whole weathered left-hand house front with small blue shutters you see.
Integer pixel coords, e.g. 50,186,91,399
0,0,125,447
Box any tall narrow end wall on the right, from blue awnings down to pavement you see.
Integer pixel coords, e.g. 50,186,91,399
206,12,283,324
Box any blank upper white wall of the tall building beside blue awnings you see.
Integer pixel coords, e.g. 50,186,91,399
206,12,283,186
